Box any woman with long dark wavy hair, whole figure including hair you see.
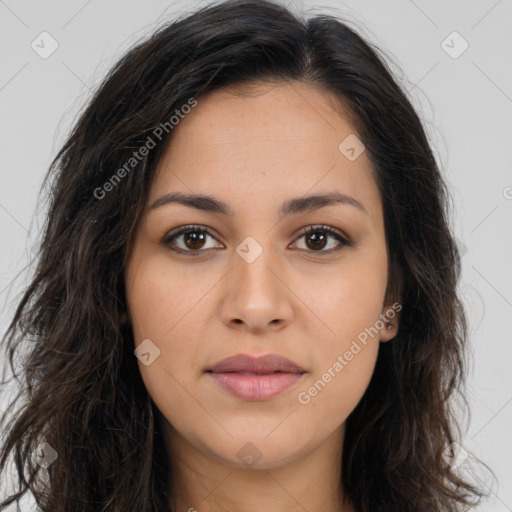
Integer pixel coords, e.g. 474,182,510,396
0,0,492,512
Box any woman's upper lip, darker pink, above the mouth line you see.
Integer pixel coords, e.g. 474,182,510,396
206,354,306,373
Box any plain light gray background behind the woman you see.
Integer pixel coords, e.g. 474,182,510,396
0,0,512,512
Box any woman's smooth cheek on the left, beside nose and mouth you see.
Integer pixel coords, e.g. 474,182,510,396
126,255,213,418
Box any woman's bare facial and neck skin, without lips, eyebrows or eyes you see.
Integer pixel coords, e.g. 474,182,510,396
125,82,399,512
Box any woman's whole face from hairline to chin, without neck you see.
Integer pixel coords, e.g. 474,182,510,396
125,83,397,469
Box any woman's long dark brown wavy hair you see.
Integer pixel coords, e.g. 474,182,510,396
0,0,496,512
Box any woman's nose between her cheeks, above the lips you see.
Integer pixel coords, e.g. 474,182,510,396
221,242,293,333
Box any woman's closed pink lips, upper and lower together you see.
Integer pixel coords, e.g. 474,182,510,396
206,354,306,401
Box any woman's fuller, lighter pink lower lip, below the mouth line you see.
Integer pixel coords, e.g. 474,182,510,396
208,372,303,401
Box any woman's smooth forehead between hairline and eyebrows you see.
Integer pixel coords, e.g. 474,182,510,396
149,82,381,226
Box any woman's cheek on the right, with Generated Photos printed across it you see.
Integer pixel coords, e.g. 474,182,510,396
290,262,386,418
